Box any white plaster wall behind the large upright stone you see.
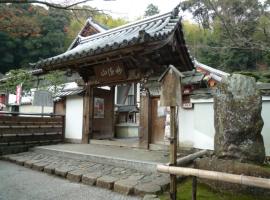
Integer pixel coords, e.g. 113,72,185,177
179,97,270,156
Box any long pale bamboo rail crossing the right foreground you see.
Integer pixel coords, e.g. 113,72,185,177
157,165,270,189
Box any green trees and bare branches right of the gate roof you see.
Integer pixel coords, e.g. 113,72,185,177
182,0,270,72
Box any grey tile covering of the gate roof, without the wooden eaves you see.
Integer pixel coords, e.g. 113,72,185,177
36,10,193,69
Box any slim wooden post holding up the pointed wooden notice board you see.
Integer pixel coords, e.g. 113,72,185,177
170,106,177,200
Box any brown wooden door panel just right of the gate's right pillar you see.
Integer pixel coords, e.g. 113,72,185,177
151,97,166,144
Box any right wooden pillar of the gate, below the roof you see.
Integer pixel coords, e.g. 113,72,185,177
139,92,151,149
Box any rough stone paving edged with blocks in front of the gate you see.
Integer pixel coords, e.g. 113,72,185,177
2,152,170,196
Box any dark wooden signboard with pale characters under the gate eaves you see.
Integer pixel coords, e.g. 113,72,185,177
94,62,126,82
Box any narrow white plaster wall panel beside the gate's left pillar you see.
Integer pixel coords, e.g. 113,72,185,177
65,96,83,140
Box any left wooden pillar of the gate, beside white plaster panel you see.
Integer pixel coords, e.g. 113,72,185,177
82,82,94,144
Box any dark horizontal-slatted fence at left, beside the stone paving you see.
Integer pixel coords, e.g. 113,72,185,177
0,112,65,154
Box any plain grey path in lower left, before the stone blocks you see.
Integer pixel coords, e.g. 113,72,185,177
0,161,140,200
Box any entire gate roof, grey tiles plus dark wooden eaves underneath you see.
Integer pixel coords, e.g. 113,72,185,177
36,8,194,75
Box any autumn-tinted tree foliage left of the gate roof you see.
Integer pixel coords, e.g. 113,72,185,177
0,4,127,73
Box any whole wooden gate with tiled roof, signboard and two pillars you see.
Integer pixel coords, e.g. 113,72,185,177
35,9,194,148
